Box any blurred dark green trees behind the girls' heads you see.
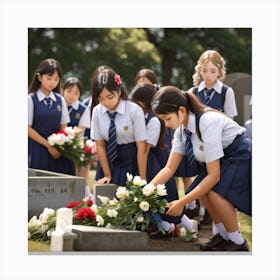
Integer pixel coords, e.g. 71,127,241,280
28,28,252,97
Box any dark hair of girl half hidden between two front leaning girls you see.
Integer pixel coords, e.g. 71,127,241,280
129,83,167,151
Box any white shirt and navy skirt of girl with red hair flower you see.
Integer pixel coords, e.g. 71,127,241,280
91,100,147,185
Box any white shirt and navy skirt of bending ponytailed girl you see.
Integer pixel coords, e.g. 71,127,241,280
172,111,252,215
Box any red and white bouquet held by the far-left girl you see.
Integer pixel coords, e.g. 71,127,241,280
47,127,96,167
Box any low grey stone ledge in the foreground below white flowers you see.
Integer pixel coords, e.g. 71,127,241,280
72,225,148,251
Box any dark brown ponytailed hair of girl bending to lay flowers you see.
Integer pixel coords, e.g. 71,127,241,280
152,86,206,115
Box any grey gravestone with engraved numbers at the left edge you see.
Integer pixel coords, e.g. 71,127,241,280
28,168,85,220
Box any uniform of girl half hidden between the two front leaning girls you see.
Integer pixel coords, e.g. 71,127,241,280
145,114,181,224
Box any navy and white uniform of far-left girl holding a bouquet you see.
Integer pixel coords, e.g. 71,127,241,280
28,90,70,173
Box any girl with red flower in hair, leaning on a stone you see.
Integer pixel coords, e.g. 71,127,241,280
91,69,147,185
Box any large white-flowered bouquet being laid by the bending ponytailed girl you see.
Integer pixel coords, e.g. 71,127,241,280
91,174,167,231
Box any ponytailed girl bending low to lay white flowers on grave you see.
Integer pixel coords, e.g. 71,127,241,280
151,86,252,251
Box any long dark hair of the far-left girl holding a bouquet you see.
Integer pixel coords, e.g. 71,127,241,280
28,58,62,93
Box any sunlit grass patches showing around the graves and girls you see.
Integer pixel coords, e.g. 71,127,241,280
28,170,252,252
